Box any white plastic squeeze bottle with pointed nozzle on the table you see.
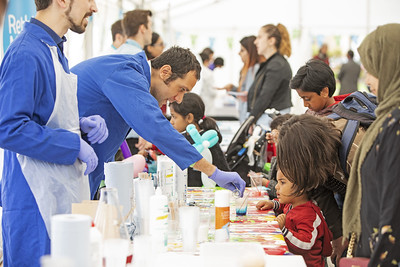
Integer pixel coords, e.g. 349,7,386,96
149,187,168,253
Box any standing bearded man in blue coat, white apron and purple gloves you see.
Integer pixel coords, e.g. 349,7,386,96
0,0,104,266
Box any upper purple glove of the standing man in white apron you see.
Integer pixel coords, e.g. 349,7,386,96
79,115,108,144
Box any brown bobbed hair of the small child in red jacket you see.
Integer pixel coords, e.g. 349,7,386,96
277,114,341,195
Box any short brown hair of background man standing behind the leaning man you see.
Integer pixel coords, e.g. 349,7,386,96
122,9,152,37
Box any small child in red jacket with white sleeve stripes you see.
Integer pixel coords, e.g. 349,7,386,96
257,114,340,267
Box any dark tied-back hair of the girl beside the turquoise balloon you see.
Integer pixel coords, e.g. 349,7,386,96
169,93,222,142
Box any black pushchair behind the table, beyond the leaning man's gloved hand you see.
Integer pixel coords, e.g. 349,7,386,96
225,111,279,186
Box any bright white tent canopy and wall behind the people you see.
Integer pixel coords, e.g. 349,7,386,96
67,0,400,85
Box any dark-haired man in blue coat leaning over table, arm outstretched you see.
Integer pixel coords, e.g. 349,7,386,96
71,46,246,201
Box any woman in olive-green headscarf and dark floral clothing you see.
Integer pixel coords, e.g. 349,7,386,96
343,24,400,266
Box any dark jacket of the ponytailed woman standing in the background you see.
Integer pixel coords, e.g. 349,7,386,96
247,52,292,119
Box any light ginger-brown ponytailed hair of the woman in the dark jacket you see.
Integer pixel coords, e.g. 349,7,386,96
261,23,292,57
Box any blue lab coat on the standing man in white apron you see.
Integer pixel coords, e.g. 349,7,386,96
0,22,80,266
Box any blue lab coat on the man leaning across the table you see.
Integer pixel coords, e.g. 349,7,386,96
71,52,202,197
